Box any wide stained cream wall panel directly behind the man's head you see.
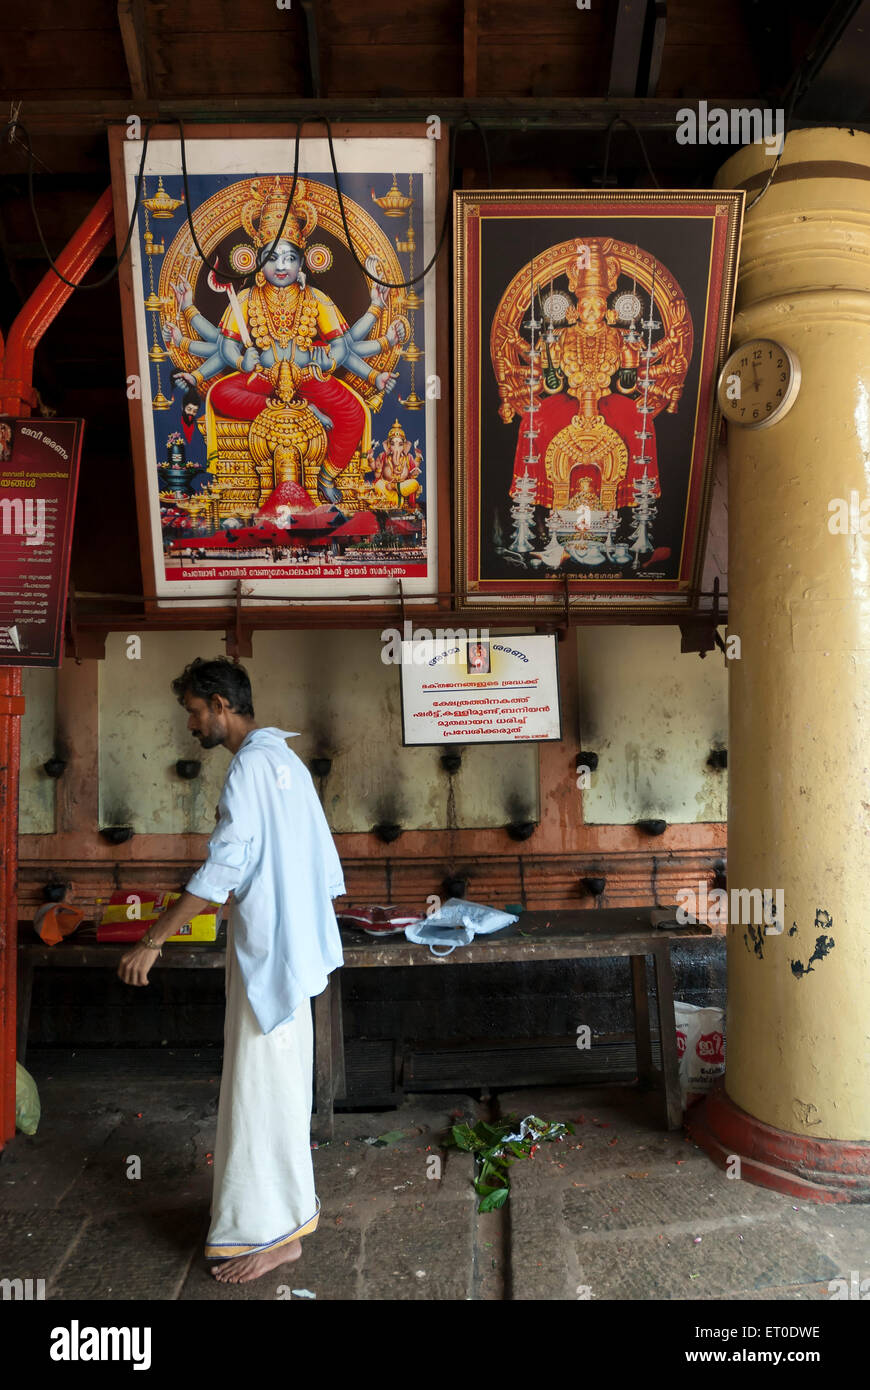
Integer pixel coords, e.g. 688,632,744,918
100,631,539,834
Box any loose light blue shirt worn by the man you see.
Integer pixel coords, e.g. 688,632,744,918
188,728,345,1033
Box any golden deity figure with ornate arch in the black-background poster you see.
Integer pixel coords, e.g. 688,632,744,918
491,236,692,518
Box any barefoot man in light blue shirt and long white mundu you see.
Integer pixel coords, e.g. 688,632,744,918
118,657,345,1283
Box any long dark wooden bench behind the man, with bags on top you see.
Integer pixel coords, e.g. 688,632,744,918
18,908,710,1138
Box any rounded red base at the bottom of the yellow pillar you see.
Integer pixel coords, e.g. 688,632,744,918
687,1087,870,1202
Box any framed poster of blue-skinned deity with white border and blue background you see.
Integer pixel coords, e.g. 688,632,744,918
111,125,449,602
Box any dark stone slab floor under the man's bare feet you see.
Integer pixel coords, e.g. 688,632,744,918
0,1051,870,1301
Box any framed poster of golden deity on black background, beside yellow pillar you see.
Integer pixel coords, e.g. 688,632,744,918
454,190,744,616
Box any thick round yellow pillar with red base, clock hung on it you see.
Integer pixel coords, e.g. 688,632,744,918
692,129,870,1201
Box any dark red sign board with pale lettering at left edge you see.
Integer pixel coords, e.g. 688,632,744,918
0,418,85,666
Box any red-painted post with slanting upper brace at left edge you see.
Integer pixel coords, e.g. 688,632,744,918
0,189,114,1150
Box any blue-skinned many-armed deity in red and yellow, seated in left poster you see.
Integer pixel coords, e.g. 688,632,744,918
163,175,409,518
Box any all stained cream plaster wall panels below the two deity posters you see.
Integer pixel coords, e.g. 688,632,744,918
19,627,727,834
